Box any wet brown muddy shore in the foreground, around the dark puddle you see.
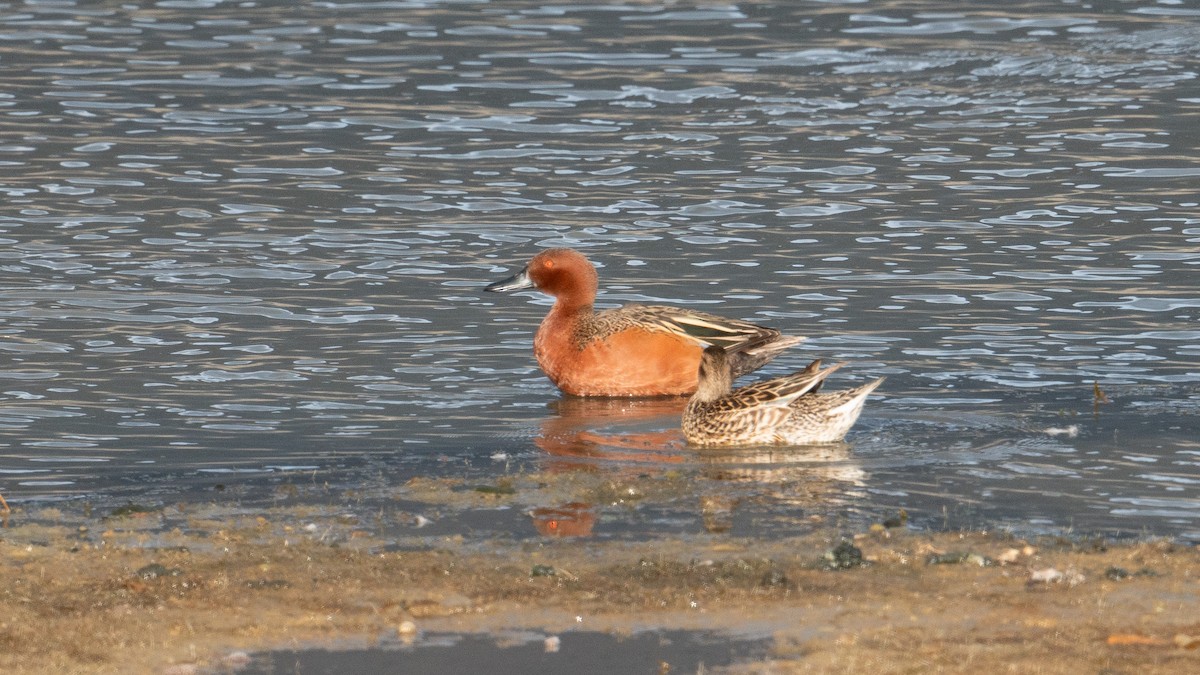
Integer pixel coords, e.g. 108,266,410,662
0,492,1200,675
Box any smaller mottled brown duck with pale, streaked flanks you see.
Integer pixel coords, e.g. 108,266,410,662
680,346,883,447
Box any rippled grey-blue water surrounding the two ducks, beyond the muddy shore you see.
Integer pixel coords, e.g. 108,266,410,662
0,0,1200,542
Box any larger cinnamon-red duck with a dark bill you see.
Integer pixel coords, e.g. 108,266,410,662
485,249,803,396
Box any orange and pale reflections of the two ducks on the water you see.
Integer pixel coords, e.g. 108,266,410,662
529,396,870,537
